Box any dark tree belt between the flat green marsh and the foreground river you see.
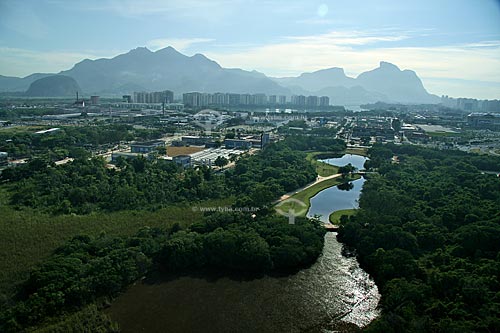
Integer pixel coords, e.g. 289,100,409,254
0,206,325,332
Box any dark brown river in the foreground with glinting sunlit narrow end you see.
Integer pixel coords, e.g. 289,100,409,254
106,154,380,332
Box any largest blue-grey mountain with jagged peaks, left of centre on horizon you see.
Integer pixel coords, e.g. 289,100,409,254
60,47,290,94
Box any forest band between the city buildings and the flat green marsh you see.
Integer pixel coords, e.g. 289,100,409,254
0,138,316,214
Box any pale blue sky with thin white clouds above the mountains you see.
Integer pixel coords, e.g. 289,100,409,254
0,0,500,99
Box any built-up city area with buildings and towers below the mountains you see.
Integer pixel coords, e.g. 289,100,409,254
0,90,500,168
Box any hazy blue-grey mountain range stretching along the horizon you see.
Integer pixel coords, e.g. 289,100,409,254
0,47,439,105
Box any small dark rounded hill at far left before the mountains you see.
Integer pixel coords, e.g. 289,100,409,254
25,75,81,97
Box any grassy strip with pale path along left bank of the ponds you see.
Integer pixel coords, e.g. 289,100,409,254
275,175,361,216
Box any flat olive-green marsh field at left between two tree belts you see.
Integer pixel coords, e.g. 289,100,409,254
0,187,234,303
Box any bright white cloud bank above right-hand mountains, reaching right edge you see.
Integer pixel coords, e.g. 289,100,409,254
206,31,500,98
